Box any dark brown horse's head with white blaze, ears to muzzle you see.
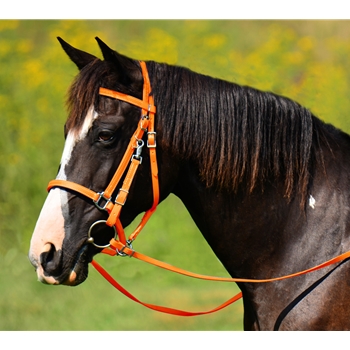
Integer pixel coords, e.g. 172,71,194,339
29,38,174,285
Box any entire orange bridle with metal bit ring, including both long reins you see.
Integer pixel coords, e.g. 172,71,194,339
47,61,350,316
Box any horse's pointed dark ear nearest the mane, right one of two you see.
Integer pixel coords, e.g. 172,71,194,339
95,37,141,83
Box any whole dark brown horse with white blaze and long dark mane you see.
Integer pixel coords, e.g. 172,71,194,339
29,38,350,330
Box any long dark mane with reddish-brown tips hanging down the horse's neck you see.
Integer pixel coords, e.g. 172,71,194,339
148,62,322,202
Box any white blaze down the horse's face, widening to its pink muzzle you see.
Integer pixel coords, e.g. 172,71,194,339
29,107,98,284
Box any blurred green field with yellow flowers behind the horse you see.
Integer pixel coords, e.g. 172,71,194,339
0,20,350,331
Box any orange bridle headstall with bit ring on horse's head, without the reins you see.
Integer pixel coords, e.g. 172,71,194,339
47,61,159,255
